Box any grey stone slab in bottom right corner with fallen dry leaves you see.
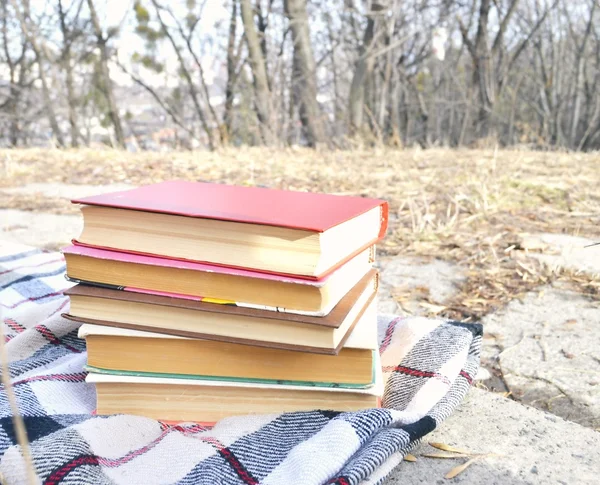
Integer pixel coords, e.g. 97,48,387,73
384,389,600,485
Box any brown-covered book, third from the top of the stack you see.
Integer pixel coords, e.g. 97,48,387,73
65,269,378,354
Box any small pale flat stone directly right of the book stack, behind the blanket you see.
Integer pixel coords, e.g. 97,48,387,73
377,257,464,315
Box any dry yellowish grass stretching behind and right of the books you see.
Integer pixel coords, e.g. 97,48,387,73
0,148,600,319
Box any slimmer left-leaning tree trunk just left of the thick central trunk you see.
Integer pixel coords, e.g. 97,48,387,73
240,0,276,145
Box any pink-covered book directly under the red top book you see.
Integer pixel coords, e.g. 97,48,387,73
62,246,375,316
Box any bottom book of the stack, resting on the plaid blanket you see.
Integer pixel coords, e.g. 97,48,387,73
86,354,383,422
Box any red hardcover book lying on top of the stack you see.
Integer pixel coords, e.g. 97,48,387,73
72,181,388,279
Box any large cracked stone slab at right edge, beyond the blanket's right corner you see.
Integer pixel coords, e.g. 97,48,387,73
482,287,600,428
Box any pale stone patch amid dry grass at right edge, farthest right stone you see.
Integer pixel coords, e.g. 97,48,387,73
524,233,600,275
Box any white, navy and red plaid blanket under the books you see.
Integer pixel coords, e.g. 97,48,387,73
0,243,481,485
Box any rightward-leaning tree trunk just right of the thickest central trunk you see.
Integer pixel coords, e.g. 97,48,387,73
348,0,385,136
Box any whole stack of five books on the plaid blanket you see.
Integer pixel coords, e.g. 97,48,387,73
63,181,388,422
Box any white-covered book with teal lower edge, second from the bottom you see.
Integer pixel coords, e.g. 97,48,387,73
79,303,377,388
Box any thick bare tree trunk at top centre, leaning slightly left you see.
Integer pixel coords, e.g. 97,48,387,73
285,0,325,147
